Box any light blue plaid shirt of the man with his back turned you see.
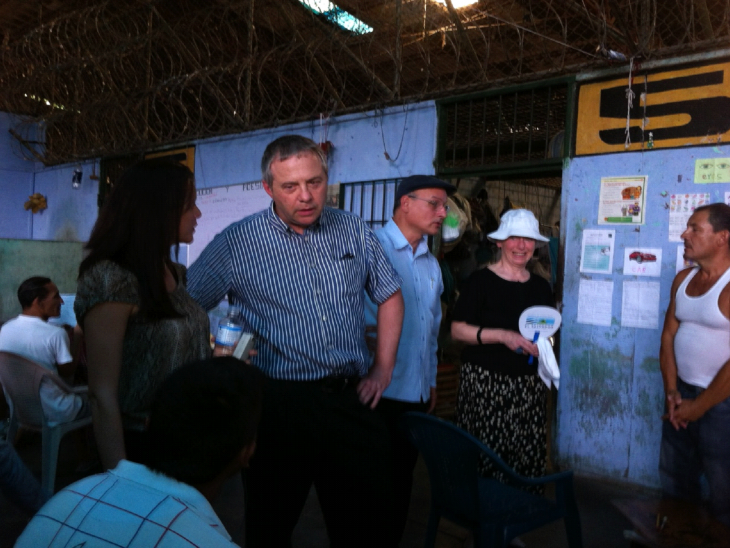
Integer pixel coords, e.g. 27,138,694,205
15,460,237,548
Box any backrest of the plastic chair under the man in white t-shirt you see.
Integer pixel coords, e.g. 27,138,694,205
0,352,73,428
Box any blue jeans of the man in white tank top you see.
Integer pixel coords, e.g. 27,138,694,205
659,379,730,526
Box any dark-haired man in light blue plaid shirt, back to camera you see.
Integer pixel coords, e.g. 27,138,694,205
15,357,264,548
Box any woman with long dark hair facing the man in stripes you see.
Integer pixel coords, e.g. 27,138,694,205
74,159,210,468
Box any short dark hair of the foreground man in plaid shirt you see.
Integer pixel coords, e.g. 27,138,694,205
142,357,264,485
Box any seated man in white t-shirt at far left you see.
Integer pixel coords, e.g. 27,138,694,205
0,276,89,424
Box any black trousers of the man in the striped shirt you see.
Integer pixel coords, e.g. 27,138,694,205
246,379,392,548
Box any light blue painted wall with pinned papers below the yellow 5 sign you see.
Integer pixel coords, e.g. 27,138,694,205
556,146,730,487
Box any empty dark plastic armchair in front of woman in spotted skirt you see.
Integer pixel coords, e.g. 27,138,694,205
400,412,583,548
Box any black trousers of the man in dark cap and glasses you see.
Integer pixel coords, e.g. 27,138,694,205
375,398,428,546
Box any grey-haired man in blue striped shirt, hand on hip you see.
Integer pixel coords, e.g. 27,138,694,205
188,135,403,548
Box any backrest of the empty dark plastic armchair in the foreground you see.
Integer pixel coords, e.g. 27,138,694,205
400,412,516,522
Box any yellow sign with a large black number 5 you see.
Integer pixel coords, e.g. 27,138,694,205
575,63,730,156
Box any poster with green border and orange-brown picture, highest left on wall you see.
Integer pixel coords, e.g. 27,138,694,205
598,175,648,225
